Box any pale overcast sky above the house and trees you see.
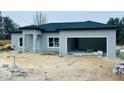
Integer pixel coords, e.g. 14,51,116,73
2,11,124,26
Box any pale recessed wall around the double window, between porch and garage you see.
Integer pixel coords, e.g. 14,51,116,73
40,32,59,52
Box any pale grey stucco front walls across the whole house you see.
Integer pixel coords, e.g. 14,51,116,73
11,30,116,57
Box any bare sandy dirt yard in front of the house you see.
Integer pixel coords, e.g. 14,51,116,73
0,52,124,81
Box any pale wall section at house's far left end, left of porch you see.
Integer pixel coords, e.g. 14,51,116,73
11,33,22,50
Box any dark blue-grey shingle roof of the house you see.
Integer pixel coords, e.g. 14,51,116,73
10,21,117,32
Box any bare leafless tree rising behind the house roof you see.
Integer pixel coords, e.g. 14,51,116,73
33,12,47,25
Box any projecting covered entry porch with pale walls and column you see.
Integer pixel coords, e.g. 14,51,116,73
23,30,41,52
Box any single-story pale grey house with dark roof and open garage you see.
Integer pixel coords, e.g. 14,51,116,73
11,21,117,57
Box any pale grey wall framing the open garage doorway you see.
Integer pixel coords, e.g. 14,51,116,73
59,30,116,58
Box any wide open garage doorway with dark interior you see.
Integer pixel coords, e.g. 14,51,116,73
67,38,107,56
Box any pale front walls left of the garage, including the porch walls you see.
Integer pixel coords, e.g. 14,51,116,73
11,30,59,52
